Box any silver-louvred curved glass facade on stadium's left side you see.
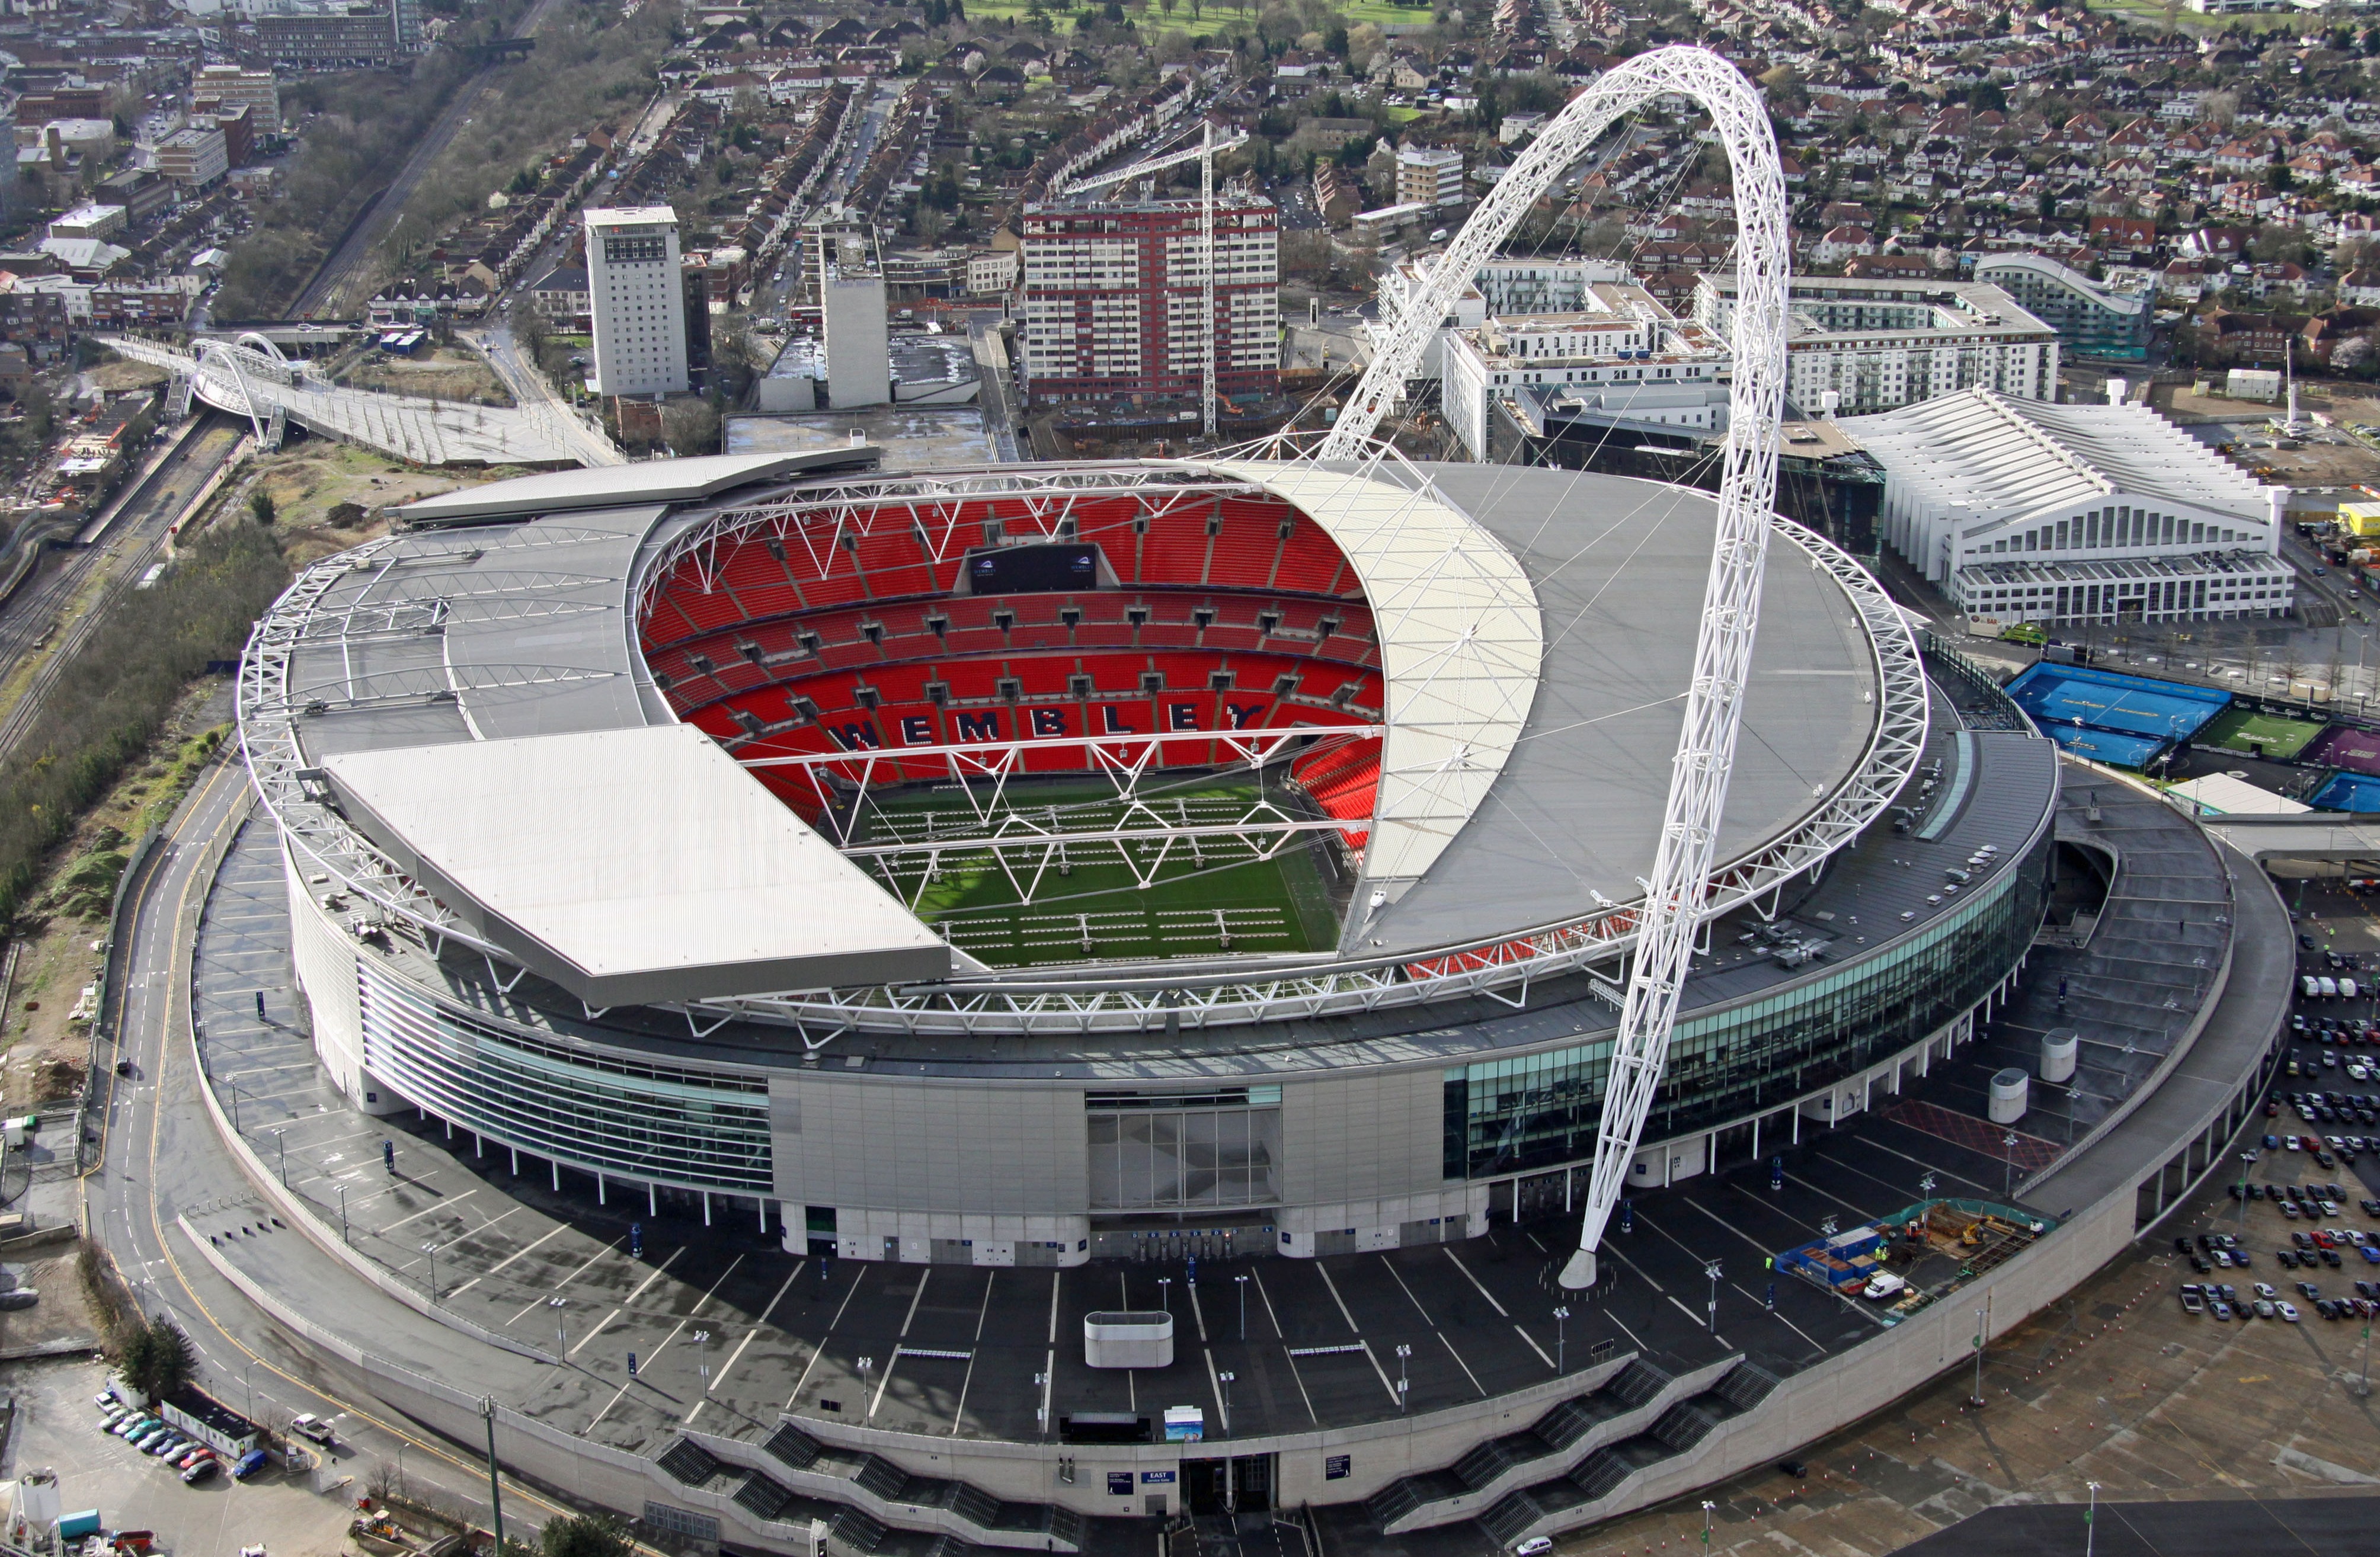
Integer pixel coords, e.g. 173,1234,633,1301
359,959,773,1195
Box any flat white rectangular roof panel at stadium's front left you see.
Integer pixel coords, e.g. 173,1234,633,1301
321,724,949,1005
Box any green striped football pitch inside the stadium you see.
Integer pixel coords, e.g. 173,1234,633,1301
859,778,1338,966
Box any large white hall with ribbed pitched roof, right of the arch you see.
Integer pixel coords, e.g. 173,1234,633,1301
1842,388,2292,624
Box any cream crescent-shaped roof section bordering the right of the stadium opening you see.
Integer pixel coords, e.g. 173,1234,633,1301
1214,462,1544,898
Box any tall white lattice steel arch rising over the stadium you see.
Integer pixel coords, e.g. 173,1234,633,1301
1316,47,1790,1288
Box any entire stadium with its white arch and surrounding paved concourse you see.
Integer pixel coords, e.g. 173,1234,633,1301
214,50,2294,1557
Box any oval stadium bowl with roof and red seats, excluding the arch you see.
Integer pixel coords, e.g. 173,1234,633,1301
241,438,2056,1264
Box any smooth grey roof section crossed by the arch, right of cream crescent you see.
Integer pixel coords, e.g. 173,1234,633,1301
1366,464,1878,950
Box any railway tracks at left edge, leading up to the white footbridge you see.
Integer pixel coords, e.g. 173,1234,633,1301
0,412,243,760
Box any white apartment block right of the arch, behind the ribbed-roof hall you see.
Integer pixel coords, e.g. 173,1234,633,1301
1694,271,2059,417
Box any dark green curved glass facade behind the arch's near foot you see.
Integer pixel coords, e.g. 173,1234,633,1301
1442,833,2049,1178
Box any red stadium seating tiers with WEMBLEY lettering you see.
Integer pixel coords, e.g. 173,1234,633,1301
642,493,1383,824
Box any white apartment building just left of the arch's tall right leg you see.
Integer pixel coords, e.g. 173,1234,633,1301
1442,281,1728,460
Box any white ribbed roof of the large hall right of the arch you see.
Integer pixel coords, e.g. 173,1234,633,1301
1842,388,2273,521
